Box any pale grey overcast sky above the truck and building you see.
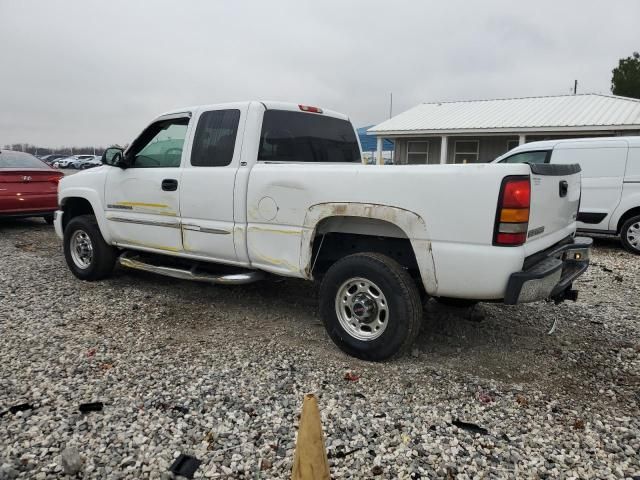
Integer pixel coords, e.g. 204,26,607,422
0,0,640,147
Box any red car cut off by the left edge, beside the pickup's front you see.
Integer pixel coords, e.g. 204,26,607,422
0,150,64,224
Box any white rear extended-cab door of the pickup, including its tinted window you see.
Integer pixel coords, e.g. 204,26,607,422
180,104,247,263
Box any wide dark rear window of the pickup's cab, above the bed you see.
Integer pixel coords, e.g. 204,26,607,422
258,110,361,163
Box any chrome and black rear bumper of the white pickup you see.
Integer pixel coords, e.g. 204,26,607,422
504,237,593,305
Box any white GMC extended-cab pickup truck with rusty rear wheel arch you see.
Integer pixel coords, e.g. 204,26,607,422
55,101,591,360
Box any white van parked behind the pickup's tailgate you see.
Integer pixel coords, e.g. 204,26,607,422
494,137,640,255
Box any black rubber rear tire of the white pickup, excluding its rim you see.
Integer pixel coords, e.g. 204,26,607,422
320,253,422,361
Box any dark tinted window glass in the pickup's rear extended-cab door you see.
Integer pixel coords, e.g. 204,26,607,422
191,110,240,167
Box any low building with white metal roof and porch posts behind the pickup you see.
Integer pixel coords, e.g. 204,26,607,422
367,94,640,164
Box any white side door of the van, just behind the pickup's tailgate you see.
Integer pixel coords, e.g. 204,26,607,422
551,140,627,230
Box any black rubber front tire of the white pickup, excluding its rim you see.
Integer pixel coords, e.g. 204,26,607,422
63,215,117,281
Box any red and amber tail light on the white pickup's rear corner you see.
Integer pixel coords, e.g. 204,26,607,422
493,177,531,247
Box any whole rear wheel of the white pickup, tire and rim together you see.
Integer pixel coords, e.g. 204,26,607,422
320,253,422,361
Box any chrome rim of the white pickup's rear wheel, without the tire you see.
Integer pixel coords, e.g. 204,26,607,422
336,277,389,342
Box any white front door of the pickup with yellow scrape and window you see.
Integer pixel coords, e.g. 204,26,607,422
104,114,190,252
